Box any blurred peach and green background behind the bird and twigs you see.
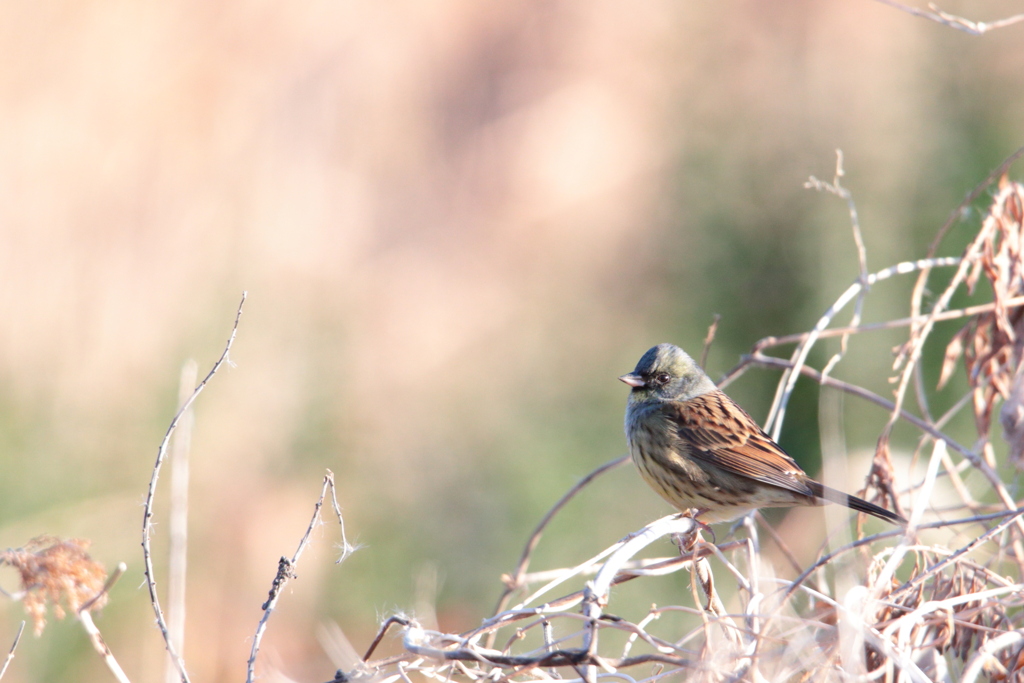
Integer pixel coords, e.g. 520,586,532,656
0,0,1024,683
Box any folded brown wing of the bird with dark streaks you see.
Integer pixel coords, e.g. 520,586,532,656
665,391,814,496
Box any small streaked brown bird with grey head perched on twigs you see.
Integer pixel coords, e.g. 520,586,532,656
618,344,906,524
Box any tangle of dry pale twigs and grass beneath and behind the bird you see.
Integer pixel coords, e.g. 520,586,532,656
338,159,1024,683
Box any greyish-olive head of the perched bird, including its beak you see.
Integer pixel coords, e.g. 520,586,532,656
618,344,716,403
